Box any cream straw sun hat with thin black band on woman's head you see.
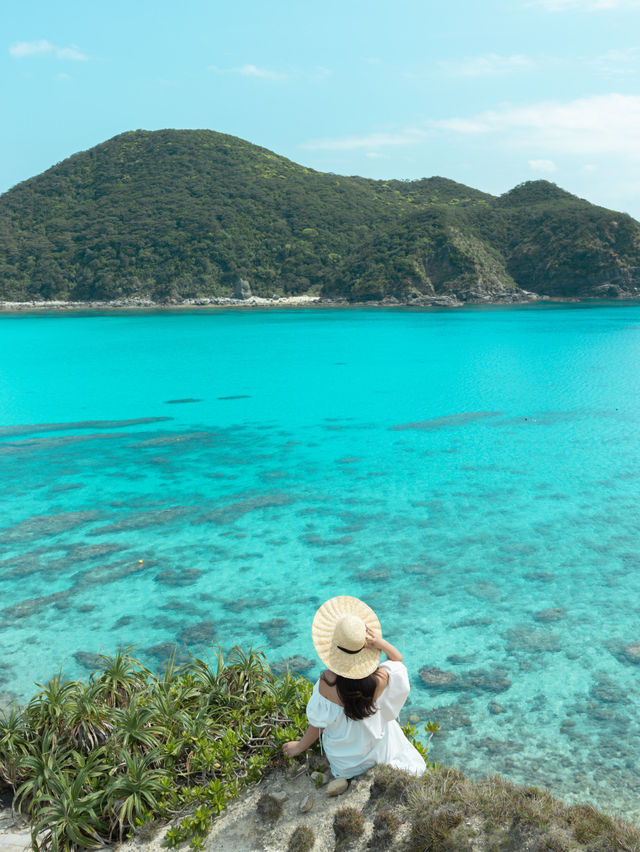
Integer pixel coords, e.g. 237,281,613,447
311,595,381,679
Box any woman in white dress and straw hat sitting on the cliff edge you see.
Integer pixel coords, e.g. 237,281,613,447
282,595,425,778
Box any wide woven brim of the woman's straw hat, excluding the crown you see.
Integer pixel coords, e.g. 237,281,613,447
311,595,382,679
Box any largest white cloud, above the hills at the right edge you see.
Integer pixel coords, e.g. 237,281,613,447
431,94,640,159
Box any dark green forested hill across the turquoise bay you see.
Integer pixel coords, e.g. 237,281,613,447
0,130,640,304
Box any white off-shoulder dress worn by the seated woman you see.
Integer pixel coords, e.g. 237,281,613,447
307,660,426,778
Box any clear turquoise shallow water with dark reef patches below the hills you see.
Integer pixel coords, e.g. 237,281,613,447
0,305,640,819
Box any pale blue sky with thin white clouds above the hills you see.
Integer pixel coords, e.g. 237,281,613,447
0,0,640,218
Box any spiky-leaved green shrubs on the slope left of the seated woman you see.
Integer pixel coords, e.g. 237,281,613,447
0,648,311,852
